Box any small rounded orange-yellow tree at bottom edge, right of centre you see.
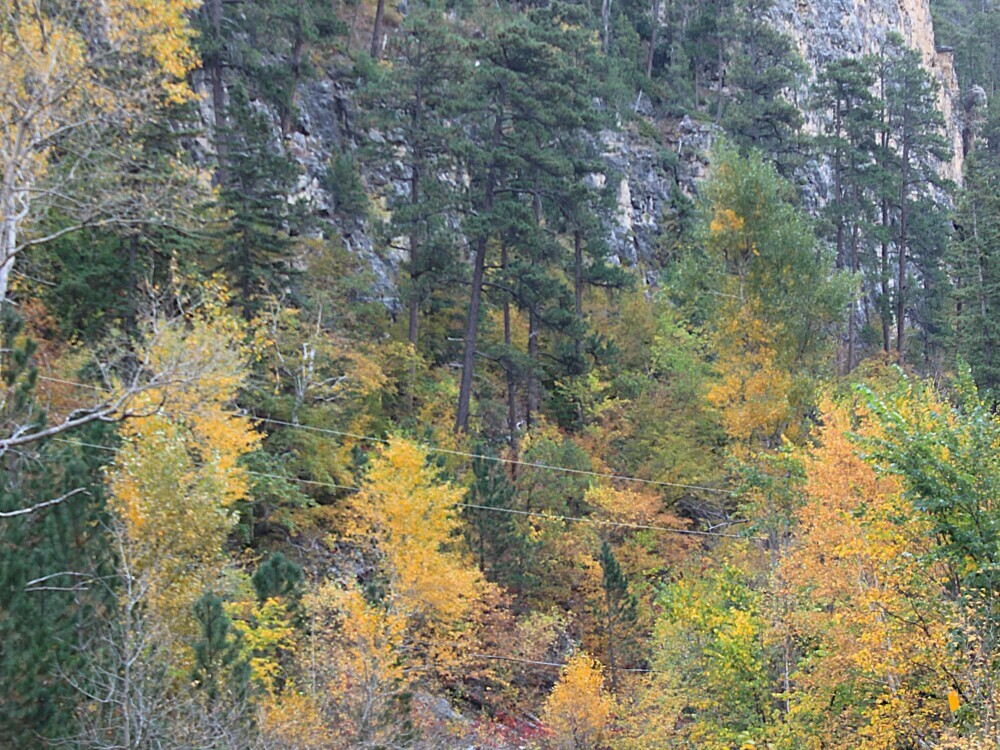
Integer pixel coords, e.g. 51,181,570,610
543,652,615,750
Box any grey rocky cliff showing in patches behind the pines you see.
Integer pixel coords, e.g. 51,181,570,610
200,0,963,290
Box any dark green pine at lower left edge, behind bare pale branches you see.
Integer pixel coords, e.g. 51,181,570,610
0,316,113,748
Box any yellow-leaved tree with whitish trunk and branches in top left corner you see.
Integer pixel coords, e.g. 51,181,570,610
0,0,199,300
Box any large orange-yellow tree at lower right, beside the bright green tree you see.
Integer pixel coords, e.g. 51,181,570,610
780,402,961,750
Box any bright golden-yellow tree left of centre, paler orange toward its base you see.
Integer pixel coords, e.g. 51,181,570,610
299,438,489,748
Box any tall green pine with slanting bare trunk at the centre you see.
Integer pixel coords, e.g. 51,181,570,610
456,3,602,430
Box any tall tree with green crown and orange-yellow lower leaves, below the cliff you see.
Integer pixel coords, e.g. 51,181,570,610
700,144,847,457
